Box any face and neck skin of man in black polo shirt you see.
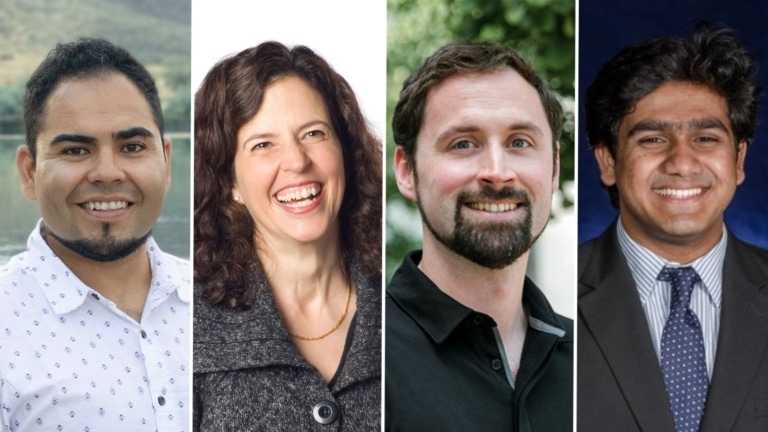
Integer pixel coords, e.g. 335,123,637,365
395,68,559,374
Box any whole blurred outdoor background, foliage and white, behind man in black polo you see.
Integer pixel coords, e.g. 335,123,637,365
386,0,576,317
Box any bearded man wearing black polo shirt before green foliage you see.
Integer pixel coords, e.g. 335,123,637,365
385,43,573,431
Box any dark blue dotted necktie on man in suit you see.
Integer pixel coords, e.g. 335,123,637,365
658,267,709,432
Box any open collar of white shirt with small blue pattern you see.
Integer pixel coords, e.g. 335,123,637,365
24,219,190,315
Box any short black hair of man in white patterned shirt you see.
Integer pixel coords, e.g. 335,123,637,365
24,38,164,159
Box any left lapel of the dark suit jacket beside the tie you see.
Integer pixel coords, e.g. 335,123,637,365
579,228,674,431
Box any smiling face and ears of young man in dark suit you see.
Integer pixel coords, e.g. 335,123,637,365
595,81,747,263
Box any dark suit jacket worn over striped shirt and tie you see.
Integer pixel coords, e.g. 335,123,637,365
577,223,768,432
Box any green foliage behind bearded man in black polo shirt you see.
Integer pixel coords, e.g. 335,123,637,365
386,0,576,279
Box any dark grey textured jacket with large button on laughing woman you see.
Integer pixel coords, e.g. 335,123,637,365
193,266,381,432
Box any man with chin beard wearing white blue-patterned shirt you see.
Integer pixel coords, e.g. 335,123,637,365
0,39,190,431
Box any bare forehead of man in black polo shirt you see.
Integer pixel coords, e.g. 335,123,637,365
420,67,552,140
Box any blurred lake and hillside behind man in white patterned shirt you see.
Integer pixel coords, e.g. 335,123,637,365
0,0,191,265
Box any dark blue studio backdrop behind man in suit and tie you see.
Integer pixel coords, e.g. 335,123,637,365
577,0,768,248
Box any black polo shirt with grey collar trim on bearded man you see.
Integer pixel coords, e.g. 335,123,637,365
384,251,573,432
